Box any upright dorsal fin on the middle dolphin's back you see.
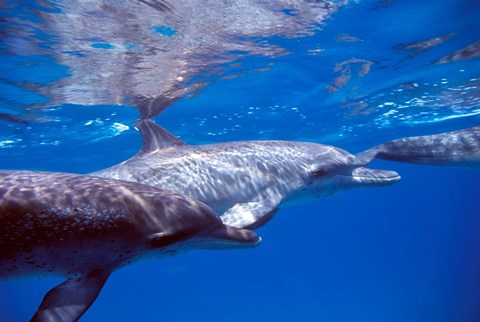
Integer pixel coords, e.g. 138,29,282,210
136,120,186,154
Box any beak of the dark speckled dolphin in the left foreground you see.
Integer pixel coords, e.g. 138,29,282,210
203,225,262,249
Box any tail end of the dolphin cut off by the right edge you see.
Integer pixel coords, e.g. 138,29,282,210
357,126,480,169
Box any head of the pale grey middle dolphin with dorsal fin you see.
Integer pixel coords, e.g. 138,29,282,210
284,144,400,204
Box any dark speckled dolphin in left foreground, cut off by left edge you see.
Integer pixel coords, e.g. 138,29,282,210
0,171,260,322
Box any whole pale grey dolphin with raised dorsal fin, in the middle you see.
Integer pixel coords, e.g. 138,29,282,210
91,120,400,229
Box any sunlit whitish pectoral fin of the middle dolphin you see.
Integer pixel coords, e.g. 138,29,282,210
220,201,278,229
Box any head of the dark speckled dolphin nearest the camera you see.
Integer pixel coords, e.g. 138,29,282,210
146,194,261,253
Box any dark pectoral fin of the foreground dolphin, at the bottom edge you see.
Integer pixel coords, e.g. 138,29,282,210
30,270,110,322
